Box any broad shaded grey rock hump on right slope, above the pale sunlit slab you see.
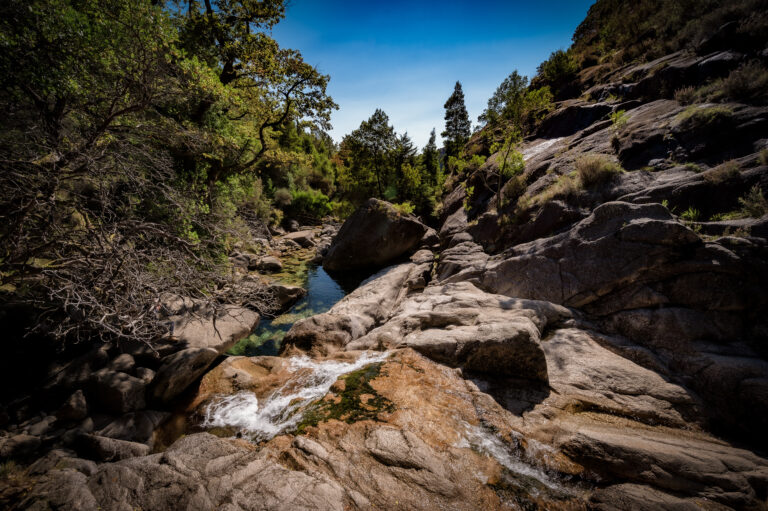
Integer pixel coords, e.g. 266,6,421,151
482,202,701,307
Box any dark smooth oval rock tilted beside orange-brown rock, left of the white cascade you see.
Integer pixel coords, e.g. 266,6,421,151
149,348,219,403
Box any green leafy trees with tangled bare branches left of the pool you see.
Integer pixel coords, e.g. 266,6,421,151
0,0,335,342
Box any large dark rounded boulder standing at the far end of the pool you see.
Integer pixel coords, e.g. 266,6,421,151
323,199,427,270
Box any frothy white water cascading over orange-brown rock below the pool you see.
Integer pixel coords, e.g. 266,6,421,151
201,352,389,441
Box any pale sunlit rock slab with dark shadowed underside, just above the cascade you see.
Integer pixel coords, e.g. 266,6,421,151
347,282,571,382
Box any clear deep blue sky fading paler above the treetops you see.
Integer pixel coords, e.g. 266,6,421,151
273,0,594,147
